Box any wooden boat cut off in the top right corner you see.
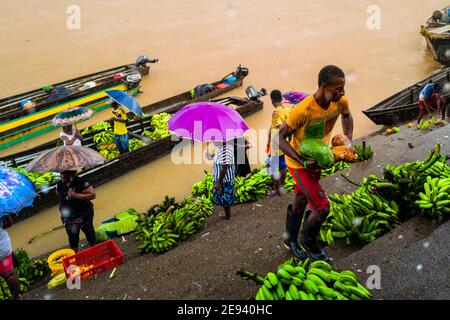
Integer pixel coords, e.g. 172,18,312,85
420,6,450,66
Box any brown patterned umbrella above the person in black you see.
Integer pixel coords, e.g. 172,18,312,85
25,146,105,173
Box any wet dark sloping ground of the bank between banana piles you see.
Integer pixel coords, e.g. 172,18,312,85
25,122,450,300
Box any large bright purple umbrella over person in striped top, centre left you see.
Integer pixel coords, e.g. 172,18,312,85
169,102,248,142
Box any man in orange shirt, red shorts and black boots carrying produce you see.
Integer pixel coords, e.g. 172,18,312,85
277,65,353,261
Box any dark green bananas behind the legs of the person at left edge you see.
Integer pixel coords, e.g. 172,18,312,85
0,249,50,300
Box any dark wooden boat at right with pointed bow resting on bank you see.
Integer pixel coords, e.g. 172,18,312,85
363,68,450,126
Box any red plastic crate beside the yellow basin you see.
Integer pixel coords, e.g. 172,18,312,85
62,240,124,281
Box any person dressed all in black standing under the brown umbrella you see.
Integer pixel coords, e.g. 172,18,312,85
56,170,96,252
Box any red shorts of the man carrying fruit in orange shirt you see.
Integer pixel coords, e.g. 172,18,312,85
289,168,330,212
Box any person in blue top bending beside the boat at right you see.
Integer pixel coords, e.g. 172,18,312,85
417,82,446,123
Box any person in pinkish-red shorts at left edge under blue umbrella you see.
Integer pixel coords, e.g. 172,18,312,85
0,216,23,300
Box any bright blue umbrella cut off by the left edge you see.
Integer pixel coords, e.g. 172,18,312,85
0,166,37,218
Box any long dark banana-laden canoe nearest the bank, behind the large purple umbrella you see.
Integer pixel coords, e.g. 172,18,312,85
8,97,263,221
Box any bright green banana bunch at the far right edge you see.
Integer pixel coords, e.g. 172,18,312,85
415,176,450,220
